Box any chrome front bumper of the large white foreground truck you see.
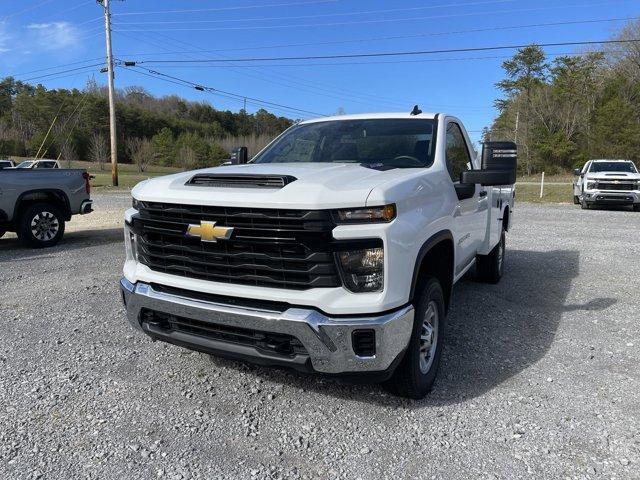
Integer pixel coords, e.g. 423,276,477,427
120,278,414,374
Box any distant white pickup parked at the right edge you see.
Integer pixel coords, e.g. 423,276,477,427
573,160,640,212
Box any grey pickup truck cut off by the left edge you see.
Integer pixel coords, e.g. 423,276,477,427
0,169,92,248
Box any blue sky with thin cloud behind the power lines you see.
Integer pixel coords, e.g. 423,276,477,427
0,0,640,139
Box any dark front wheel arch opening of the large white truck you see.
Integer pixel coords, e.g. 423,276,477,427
409,230,455,310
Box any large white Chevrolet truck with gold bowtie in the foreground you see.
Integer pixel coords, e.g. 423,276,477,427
121,109,516,398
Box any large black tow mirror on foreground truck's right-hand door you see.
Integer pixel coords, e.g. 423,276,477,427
460,142,518,187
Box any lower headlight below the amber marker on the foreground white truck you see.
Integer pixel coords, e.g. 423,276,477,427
337,247,384,293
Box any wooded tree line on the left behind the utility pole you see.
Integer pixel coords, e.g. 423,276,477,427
0,81,292,171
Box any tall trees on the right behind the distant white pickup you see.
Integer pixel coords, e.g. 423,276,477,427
484,21,640,174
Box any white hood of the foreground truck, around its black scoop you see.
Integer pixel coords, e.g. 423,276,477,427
132,163,421,209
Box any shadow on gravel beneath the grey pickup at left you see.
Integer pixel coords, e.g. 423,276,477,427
0,227,124,262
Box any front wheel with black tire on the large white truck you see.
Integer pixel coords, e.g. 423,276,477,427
389,277,446,400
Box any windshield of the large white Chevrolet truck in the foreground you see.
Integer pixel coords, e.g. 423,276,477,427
252,119,436,169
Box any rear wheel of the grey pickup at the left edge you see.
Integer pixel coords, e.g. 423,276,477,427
17,203,65,248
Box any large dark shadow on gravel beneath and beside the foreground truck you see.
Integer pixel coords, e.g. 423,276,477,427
214,250,617,408
